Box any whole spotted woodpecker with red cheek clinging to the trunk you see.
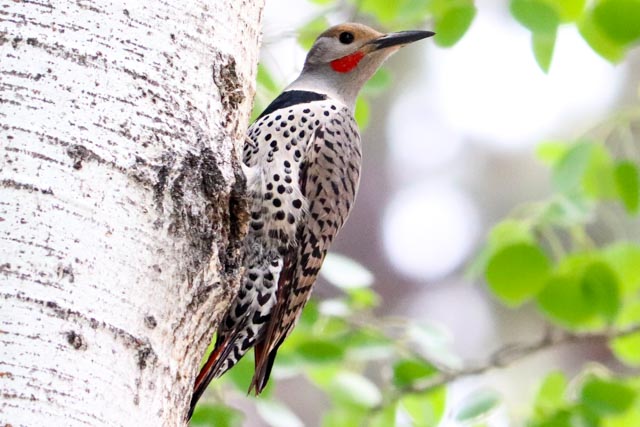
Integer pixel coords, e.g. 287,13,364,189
190,23,434,414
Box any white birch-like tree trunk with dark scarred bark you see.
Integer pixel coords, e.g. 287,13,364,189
0,0,262,427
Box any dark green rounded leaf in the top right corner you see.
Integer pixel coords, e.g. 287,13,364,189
593,0,640,45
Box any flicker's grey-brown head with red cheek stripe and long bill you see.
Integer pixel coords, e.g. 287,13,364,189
294,23,435,105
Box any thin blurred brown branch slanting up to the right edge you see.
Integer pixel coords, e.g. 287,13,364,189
375,324,640,410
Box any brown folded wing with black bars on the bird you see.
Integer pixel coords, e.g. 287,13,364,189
251,108,362,393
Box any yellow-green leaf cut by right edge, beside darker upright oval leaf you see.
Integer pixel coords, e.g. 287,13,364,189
602,242,640,296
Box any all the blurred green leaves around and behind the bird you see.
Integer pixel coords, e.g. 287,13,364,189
191,0,640,427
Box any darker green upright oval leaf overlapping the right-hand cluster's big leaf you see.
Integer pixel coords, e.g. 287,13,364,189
580,261,621,322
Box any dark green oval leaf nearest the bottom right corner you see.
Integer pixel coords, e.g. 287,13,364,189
580,376,636,416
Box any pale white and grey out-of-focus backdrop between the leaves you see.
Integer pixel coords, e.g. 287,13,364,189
199,0,640,426
